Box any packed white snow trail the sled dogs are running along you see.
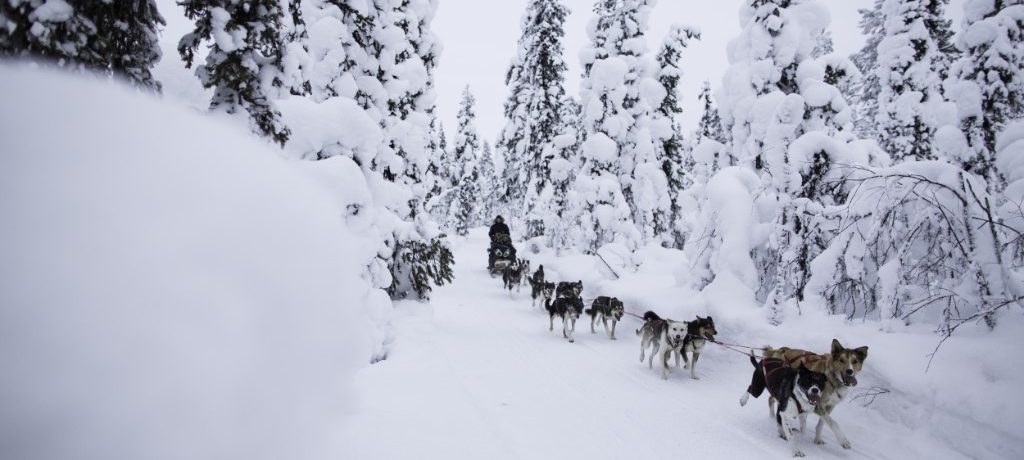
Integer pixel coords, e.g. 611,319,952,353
344,229,995,460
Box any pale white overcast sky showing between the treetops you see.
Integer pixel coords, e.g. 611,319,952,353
432,0,963,144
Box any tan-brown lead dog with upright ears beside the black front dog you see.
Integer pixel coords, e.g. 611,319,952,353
765,339,867,449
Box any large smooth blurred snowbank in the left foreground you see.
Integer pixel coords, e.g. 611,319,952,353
0,67,374,459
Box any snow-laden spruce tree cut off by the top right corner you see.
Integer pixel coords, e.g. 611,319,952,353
947,0,1024,191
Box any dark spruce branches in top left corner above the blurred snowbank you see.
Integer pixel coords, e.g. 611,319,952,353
0,0,165,91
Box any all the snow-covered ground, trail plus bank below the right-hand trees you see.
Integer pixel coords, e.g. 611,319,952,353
344,228,1024,459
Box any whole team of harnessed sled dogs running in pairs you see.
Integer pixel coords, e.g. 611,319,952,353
493,254,867,457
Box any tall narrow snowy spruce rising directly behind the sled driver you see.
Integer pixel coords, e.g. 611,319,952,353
497,0,568,238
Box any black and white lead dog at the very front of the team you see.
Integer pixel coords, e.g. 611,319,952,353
739,357,828,457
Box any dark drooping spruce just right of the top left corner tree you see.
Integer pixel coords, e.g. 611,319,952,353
178,0,290,145
